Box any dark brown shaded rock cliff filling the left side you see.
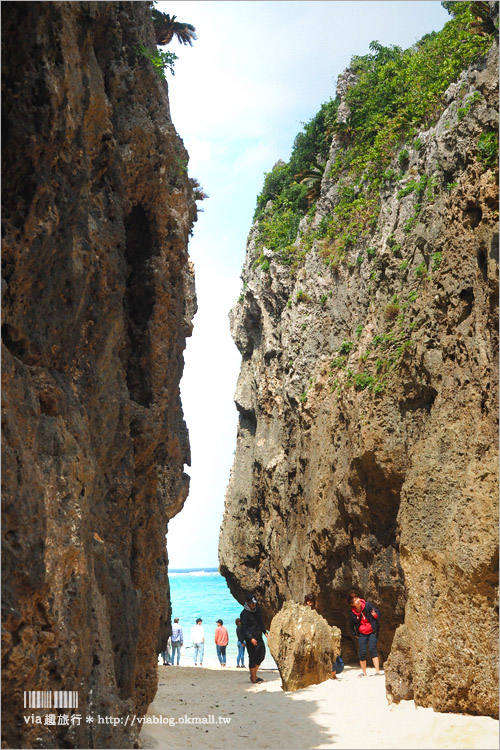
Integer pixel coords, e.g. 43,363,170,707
2,2,196,748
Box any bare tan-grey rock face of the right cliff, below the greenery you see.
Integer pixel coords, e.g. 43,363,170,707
219,42,498,715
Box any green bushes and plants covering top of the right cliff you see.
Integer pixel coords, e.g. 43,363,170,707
254,2,498,265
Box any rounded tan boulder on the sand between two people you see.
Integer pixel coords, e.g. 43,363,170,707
267,602,340,690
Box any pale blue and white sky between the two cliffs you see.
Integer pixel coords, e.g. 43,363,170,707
161,0,449,569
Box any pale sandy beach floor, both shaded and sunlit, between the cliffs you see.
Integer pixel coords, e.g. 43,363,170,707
140,666,499,750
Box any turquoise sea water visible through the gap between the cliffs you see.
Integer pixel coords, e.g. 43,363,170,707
168,568,276,669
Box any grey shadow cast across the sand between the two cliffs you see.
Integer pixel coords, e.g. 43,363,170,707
140,667,335,750
